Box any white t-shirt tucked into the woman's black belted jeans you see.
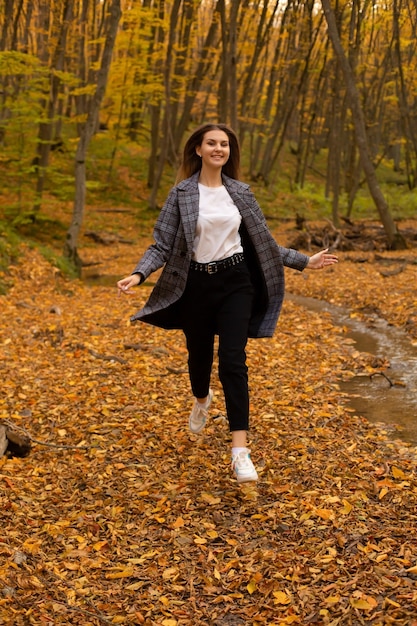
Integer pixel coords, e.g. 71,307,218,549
193,183,243,263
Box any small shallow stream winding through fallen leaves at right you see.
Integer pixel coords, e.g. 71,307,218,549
286,294,417,445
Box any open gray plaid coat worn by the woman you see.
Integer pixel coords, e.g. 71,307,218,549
131,172,309,337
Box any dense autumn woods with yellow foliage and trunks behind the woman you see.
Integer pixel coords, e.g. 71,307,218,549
0,0,417,260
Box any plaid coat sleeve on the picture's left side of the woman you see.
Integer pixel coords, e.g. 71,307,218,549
132,187,180,279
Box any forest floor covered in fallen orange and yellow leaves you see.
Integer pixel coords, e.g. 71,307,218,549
0,211,417,626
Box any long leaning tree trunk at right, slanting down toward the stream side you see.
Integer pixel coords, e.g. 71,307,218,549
321,0,406,250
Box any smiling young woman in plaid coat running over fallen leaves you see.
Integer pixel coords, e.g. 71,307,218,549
117,124,337,483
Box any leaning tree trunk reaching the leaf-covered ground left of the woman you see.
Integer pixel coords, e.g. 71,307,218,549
64,0,121,273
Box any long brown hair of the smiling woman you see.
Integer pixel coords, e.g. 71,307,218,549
177,124,240,183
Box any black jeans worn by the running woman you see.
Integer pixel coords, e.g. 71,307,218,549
182,262,254,431
